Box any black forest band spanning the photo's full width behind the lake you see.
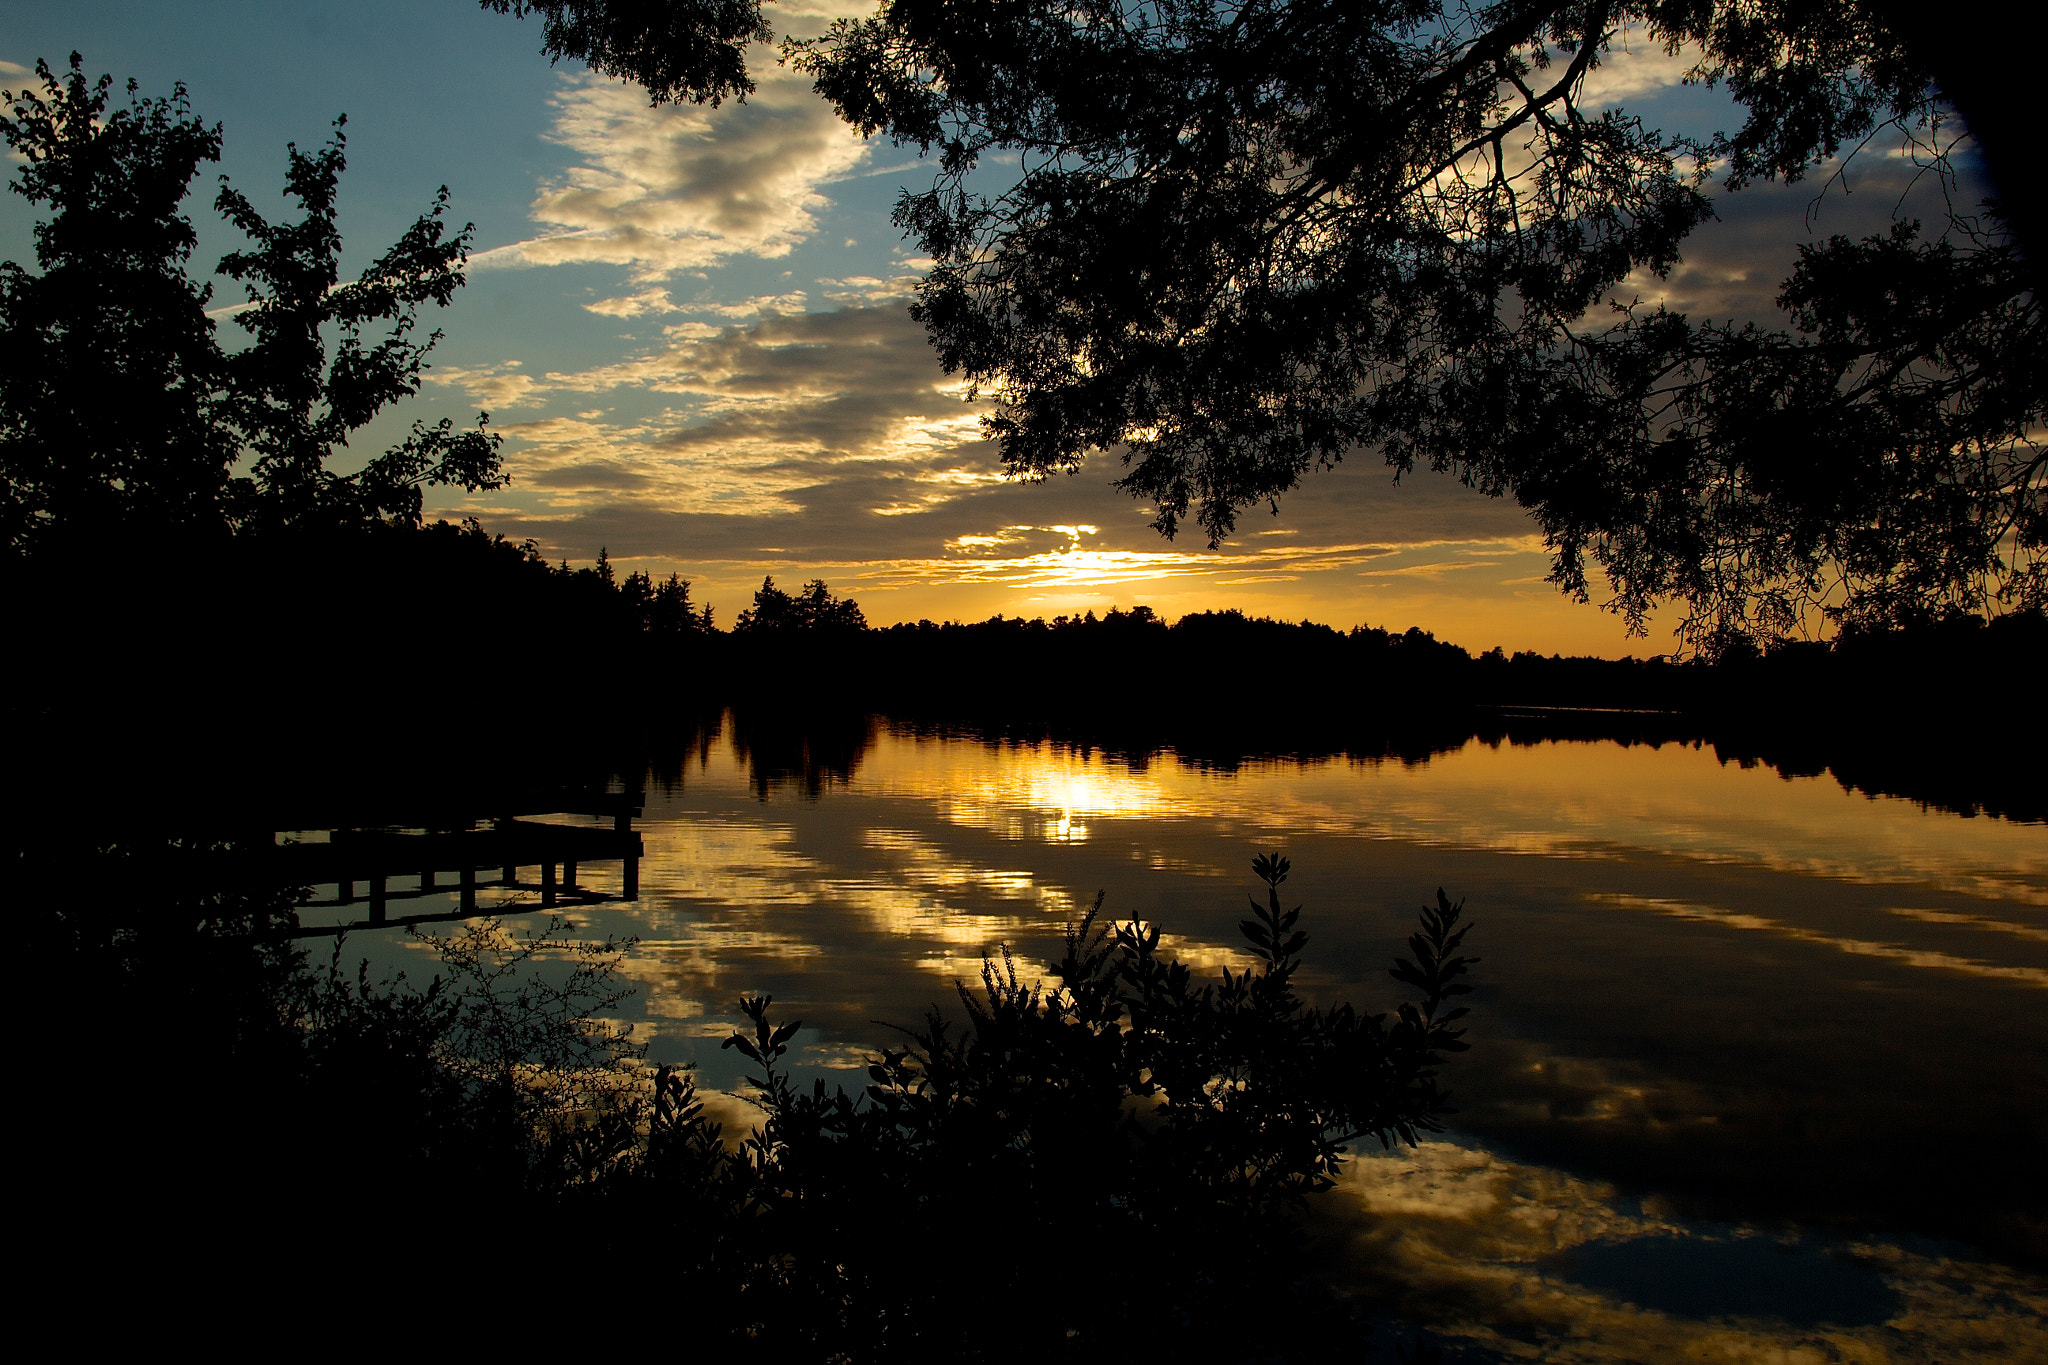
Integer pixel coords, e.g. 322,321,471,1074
0,522,2048,819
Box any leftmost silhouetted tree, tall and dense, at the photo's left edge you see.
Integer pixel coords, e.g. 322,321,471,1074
0,61,238,548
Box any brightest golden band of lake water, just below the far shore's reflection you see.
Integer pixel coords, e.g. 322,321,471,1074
854,735,2048,905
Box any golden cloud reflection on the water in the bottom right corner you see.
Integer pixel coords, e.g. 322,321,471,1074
1337,1142,2048,1365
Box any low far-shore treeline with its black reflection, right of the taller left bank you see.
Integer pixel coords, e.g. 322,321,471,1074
708,589,2048,821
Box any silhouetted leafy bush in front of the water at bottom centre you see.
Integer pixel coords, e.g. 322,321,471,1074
727,855,1475,1216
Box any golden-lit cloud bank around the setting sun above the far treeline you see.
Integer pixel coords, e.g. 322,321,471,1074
461,307,1530,610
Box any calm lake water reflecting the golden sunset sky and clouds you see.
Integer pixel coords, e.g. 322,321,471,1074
296,729,2048,1361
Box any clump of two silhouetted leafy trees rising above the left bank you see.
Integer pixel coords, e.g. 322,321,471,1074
0,53,504,553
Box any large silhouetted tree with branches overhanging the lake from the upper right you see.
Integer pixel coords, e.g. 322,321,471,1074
500,0,2048,649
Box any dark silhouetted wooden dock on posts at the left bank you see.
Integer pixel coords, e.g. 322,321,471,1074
264,794,645,937
